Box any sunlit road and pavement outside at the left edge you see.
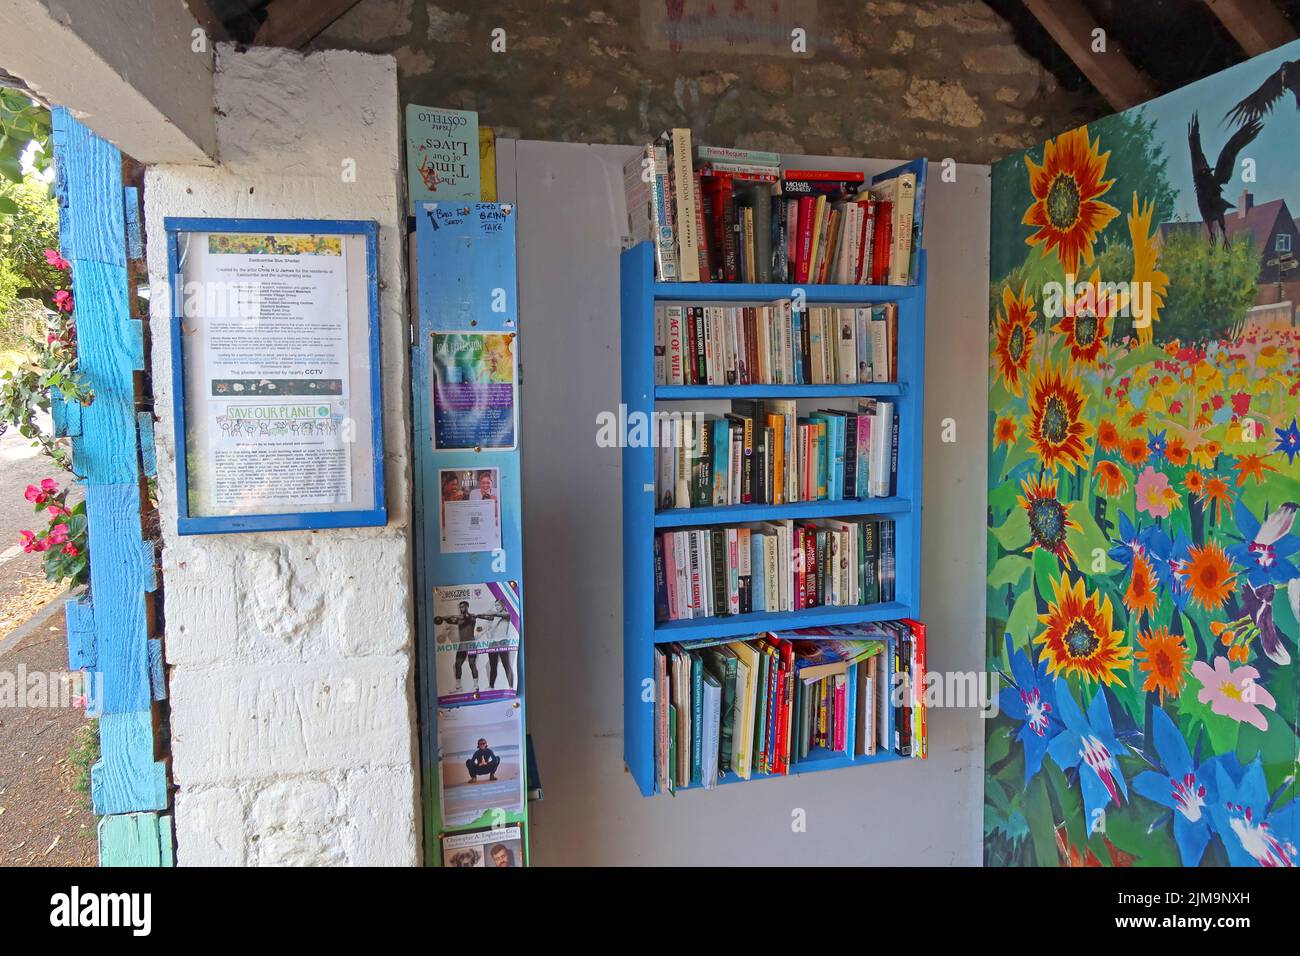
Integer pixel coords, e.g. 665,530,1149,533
0,421,96,866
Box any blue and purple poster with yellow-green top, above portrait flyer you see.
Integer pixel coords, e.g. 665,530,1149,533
429,332,519,450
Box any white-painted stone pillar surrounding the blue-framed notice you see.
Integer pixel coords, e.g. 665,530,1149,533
144,47,420,865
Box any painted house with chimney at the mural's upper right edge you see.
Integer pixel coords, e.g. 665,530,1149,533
1160,190,1300,325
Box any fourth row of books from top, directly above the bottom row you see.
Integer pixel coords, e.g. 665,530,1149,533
654,518,897,623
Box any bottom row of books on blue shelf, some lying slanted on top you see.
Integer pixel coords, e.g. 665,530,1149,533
654,620,927,793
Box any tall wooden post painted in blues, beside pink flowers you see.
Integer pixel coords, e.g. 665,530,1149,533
52,108,172,866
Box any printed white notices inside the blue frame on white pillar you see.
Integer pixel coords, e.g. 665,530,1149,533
185,233,354,514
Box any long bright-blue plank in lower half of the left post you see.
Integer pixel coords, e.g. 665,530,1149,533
86,481,155,712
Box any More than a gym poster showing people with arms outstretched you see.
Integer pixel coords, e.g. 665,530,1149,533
433,581,520,706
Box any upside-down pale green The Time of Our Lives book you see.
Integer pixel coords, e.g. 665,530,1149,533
407,103,481,215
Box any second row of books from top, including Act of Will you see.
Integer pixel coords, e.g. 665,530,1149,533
654,299,898,385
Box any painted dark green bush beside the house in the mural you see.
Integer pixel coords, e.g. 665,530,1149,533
1153,230,1260,342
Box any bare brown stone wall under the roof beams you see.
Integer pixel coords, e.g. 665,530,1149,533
315,0,1109,163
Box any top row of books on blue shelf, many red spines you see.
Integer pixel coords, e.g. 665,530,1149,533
623,127,924,285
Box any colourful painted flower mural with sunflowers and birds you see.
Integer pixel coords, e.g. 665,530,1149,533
984,43,1300,866
